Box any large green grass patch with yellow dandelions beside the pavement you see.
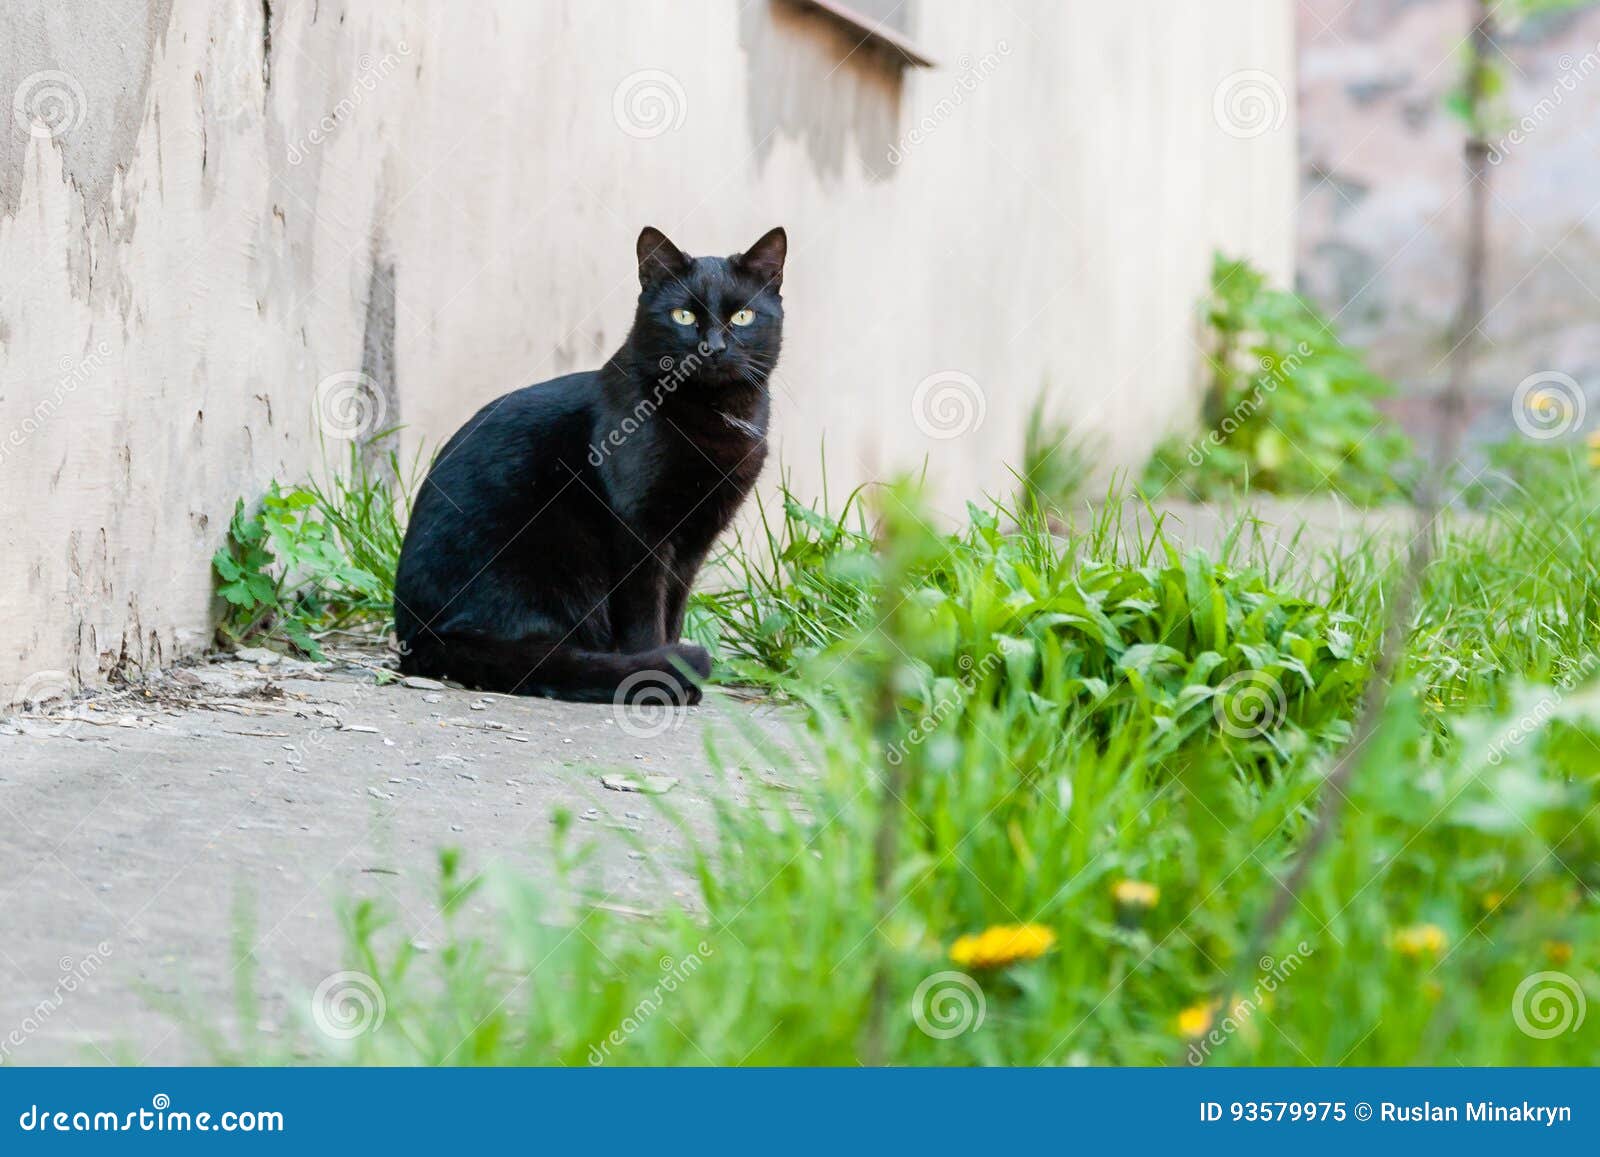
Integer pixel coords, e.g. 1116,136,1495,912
209,444,1600,1064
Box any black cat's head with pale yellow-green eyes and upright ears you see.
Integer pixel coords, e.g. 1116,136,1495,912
634,226,789,389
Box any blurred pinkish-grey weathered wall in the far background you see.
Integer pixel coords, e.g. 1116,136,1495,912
1298,0,1600,437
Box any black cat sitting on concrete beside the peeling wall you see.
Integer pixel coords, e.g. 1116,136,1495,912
395,229,789,703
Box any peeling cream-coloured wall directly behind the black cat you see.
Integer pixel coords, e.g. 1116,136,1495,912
0,0,1294,698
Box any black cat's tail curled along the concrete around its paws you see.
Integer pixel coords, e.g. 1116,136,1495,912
400,629,710,704
